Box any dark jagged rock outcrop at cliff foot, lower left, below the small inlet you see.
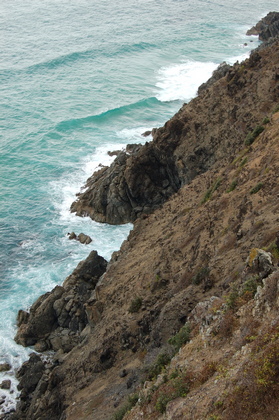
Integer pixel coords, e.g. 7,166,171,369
15,251,107,352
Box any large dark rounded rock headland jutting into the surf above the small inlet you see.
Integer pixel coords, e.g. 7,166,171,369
71,144,180,224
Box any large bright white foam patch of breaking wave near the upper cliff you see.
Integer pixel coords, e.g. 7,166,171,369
156,60,218,101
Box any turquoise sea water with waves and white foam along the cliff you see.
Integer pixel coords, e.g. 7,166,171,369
0,0,277,411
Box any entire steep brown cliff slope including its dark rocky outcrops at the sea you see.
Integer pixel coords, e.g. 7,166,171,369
6,18,279,420
